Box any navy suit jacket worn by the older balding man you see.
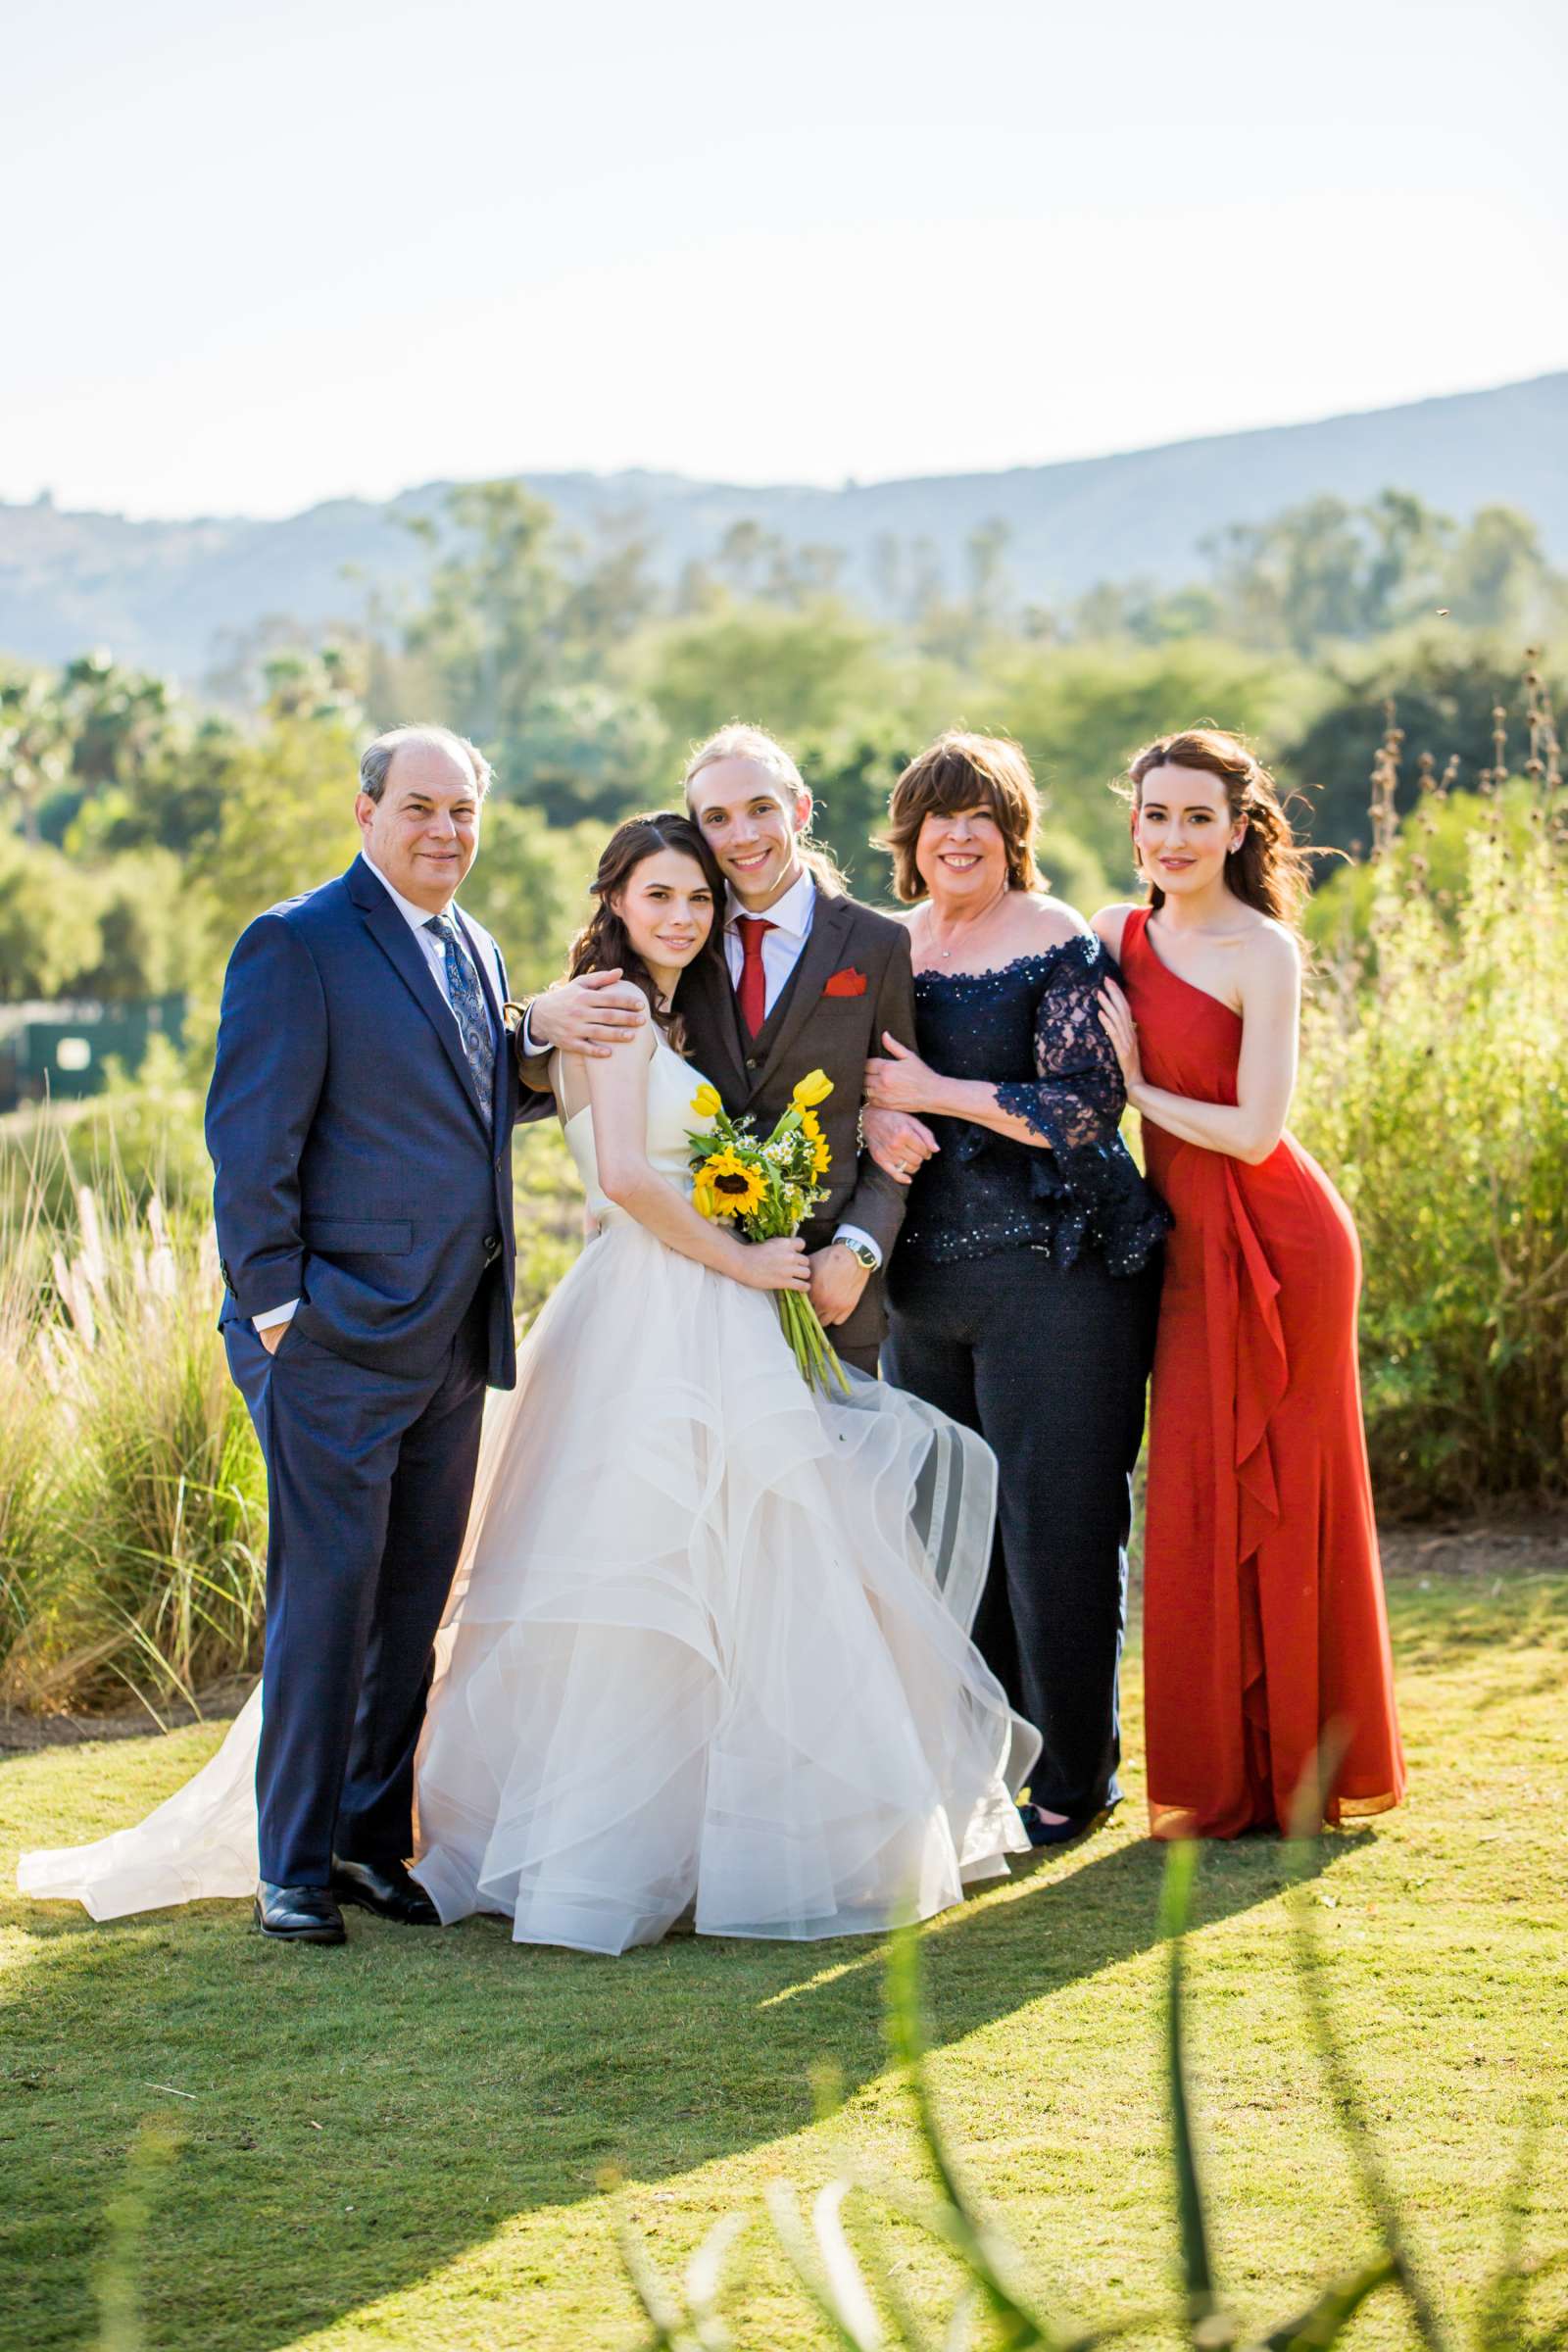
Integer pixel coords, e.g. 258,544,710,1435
207,858,517,1388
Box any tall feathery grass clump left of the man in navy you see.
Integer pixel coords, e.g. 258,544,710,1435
0,1174,266,1710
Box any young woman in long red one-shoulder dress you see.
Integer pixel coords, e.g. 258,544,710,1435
1096,727,1405,1837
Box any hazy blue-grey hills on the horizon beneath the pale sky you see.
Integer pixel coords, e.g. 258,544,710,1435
0,371,1568,682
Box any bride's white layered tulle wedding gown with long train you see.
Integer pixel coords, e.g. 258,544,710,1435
19,1040,1039,1952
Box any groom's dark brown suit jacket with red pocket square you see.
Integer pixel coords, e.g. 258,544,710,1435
522,887,914,1350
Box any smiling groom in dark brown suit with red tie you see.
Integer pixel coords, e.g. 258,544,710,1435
519,727,914,1376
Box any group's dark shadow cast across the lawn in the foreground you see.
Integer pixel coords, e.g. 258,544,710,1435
0,1788,1368,2352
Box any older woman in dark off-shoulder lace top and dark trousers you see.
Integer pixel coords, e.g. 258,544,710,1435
865,734,1168,1844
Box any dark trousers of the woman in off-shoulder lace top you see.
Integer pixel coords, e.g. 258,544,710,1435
882,1249,1159,1813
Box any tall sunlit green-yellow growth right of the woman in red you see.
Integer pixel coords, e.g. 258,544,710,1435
1296,675,1568,1515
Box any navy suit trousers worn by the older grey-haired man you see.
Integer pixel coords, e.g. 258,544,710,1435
223,1275,494,1886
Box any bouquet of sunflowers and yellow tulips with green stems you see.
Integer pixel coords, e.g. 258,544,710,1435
686,1070,849,1395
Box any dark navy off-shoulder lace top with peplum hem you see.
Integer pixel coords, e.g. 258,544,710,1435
898,934,1171,1275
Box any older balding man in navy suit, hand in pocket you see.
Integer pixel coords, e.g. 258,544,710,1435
207,727,647,1942
